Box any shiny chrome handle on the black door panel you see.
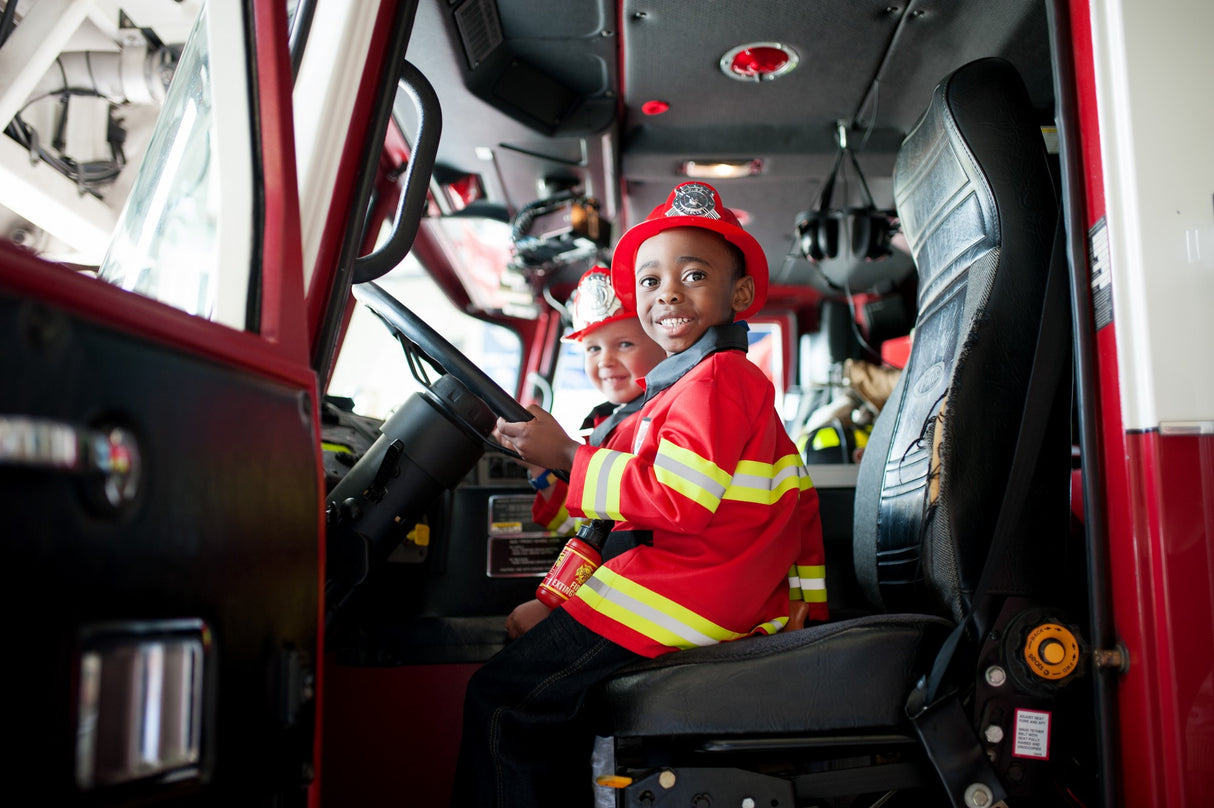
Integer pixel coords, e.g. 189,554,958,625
0,415,141,508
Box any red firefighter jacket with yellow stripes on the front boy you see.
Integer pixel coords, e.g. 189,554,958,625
563,324,827,656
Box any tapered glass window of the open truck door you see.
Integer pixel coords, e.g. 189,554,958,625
101,2,260,330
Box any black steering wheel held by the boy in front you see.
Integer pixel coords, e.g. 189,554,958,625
353,281,533,444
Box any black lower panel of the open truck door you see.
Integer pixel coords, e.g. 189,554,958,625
0,261,319,804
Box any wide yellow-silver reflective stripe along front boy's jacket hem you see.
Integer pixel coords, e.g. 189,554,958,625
578,567,745,648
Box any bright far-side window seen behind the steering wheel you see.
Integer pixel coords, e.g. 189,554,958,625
328,255,522,419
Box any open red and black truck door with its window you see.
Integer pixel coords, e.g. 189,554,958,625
0,2,323,806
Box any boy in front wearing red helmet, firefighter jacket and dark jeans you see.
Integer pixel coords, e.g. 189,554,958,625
454,182,827,806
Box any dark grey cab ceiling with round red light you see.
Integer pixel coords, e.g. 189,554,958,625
407,0,1053,286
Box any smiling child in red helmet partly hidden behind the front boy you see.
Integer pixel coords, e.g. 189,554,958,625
506,267,666,639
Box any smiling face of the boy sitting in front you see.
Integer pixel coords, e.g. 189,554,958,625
635,227,754,355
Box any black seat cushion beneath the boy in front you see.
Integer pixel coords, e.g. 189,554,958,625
599,614,952,738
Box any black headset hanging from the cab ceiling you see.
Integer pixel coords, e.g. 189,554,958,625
796,121,896,262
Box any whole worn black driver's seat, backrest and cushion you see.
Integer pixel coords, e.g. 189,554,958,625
601,59,1070,804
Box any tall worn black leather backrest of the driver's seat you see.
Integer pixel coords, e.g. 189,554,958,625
853,59,1070,620
